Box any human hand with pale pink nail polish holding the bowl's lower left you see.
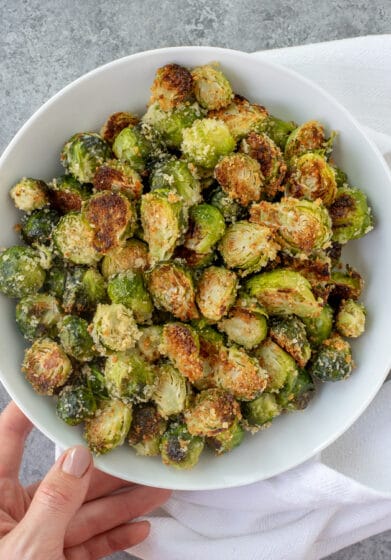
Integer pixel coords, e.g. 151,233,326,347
0,403,170,560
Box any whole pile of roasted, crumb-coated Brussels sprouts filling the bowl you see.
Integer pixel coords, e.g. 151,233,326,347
0,64,372,468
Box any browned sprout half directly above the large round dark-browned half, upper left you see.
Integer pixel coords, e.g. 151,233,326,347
92,159,143,200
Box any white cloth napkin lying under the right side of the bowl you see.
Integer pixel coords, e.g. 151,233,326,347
129,35,391,560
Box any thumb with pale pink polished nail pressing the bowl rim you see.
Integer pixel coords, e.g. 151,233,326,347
22,445,93,542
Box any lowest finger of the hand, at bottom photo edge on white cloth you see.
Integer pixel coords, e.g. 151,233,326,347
65,521,149,560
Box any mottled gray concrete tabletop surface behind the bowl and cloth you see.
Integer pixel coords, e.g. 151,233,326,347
0,0,391,560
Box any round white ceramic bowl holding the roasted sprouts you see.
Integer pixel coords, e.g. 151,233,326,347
0,47,391,490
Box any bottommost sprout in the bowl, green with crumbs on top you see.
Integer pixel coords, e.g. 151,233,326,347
160,422,204,469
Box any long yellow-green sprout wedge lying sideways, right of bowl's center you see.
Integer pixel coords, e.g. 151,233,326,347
246,268,322,317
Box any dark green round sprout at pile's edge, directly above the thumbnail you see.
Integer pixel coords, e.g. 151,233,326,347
56,385,97,426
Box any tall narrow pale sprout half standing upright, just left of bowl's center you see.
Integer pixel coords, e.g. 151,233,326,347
141,189,183,263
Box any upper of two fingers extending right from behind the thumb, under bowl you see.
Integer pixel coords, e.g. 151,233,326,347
65,486,171,547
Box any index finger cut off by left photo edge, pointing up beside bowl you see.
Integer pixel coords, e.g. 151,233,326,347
0,402,32,478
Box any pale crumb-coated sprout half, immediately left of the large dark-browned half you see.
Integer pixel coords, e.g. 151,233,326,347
53,212,101,265
